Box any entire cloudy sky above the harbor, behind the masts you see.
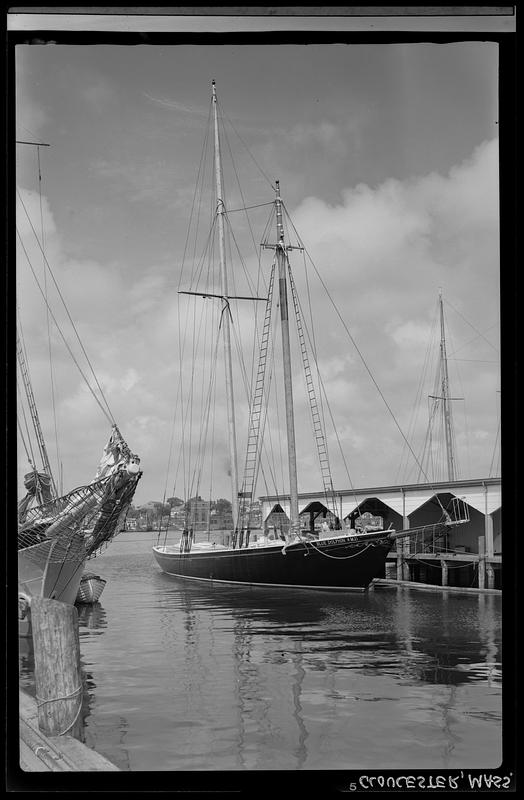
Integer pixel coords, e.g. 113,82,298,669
16,41,500,505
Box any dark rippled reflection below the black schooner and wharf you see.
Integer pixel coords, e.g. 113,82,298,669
161,582,501,685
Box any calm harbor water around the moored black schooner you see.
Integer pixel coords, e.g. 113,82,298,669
19,532,502,772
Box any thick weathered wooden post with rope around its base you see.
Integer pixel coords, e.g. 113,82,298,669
31,597,83,741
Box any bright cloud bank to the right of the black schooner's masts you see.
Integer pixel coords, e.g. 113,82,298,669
286,140,499,483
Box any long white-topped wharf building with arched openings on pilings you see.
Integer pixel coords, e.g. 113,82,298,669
259,478,502,589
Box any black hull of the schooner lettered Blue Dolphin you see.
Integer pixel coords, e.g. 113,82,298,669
153,536,392,591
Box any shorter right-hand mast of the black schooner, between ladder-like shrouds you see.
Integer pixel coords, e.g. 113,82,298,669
276,181,300,533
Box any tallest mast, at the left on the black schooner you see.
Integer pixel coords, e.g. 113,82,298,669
212,81,238,529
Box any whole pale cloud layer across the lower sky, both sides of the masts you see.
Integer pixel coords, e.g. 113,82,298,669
17,134,499,500
